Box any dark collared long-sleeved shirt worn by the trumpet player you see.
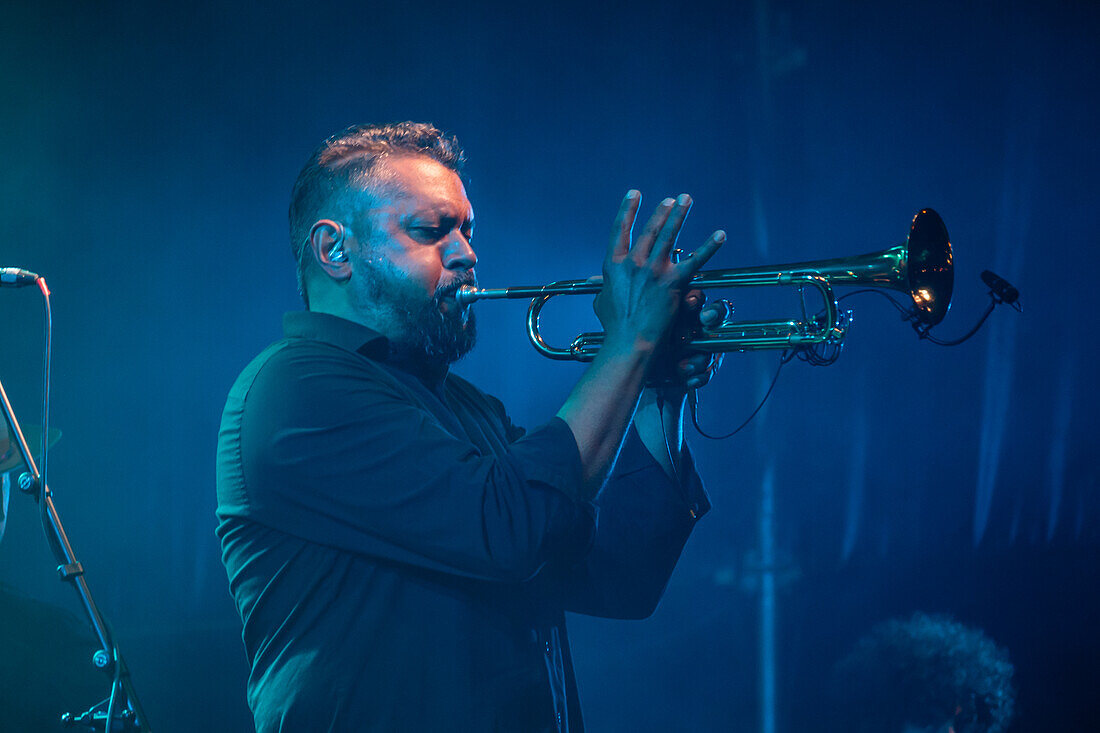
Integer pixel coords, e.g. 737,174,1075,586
218,313,708,733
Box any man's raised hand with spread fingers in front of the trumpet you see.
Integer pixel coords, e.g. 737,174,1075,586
594,190,726,353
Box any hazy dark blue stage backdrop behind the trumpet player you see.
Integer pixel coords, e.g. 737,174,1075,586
0,0,1100,731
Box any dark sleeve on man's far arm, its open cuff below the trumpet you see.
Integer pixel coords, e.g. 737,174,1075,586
547,426,711,619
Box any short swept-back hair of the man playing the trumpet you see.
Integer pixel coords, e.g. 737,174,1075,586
289,122,465,308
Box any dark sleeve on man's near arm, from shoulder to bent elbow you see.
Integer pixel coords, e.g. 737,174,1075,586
219,346,594,581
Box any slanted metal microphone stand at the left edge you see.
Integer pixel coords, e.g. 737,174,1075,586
0,374,152,733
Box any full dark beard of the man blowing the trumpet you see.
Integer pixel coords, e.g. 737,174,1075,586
362,259,477,369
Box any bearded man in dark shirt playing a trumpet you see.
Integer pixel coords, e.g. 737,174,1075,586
218,122,725,733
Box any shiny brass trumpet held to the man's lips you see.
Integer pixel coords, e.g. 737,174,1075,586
455,209,955,361
